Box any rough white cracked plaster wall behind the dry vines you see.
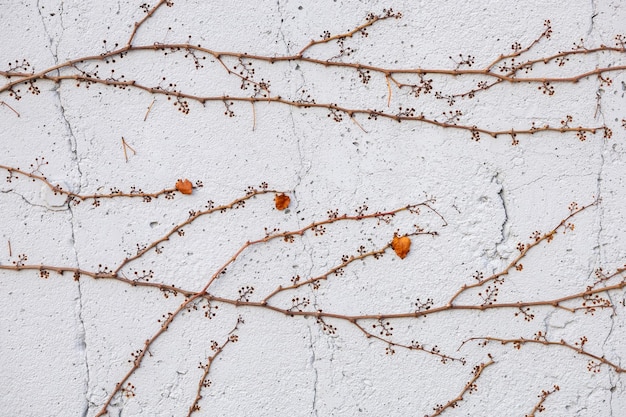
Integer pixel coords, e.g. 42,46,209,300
0,0,626,417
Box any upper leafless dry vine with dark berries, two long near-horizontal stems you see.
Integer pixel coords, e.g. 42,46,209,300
0,1,626,141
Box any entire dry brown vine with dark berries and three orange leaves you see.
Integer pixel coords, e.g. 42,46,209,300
0,0,626,416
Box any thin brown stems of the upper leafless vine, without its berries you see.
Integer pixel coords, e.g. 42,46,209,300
0,11,626,139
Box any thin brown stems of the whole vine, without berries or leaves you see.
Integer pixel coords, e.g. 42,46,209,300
0,4,626,416
